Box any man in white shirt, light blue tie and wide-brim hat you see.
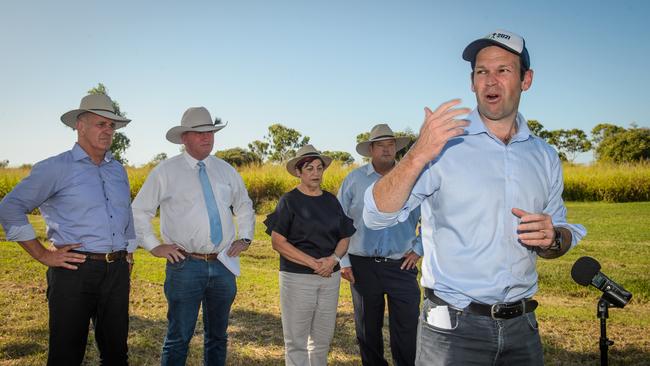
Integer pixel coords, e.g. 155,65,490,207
133,107,255,365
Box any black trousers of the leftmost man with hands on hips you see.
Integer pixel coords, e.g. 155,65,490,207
47,259,130,365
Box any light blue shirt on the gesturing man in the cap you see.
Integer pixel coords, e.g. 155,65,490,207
364,110,586,308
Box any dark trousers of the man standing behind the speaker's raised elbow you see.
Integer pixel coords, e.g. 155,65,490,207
350,255,420,366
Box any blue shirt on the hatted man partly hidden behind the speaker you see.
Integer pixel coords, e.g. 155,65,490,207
338,163,423,267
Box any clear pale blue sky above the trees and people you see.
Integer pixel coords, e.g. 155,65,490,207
0,0,650,166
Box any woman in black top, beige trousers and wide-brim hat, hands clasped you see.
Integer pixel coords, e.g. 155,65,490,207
264,145,355,366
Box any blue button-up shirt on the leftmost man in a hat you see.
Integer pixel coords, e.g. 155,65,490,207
0,144,136,253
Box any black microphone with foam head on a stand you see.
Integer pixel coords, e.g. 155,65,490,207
571,257,632,308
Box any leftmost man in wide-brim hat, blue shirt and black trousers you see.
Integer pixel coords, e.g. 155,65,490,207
0,94,136,365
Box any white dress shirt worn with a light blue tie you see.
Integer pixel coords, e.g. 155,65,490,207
132,152,255,254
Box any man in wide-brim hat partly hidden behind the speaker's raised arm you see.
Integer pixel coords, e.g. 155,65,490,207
338,124,423,365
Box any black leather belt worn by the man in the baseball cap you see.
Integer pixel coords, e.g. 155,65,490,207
424,287,539,319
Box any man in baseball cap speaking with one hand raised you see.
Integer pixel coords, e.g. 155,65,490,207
364,30,586,365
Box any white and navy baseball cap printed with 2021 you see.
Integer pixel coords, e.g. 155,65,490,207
463,29,530,70
